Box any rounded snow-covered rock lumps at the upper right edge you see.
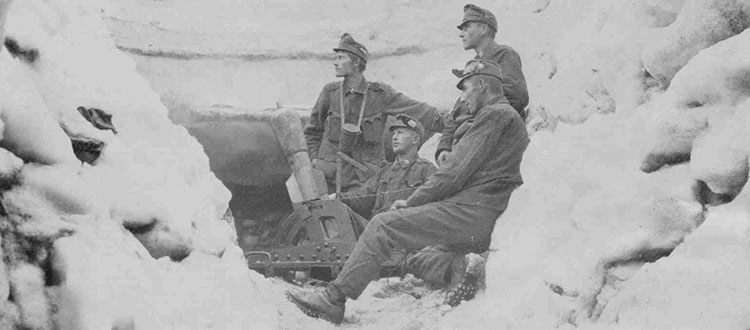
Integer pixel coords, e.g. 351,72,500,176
641,27,750,196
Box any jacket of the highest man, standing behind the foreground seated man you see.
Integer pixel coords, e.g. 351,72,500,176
435,42,529,157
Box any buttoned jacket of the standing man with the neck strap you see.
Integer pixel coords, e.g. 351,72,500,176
305,79,443,191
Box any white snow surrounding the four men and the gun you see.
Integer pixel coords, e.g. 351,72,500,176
0,0,750,329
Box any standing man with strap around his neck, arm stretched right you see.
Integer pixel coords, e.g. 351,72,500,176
305,33,443,192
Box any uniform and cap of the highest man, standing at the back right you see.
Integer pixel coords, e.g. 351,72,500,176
435,4,529,157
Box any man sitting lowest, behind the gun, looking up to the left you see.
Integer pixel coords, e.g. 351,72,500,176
334,115,437,234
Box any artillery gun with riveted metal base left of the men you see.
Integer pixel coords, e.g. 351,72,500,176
183,107,406,281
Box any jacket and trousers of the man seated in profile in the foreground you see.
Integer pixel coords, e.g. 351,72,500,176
333,85,529,299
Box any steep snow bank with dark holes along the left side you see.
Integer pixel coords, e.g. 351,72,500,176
0,0,277,329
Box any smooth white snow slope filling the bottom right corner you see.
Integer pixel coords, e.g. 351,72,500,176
601,189,750,329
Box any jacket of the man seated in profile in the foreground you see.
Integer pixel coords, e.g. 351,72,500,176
406,96,529,209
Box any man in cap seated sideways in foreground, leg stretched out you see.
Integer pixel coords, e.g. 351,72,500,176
286,60,529,324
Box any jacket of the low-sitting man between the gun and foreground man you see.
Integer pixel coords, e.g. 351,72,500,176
339,158,437,218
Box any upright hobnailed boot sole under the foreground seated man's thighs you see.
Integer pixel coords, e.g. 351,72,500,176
444,253,484,307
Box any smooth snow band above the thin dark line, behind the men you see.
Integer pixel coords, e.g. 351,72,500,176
105,0,460,60
